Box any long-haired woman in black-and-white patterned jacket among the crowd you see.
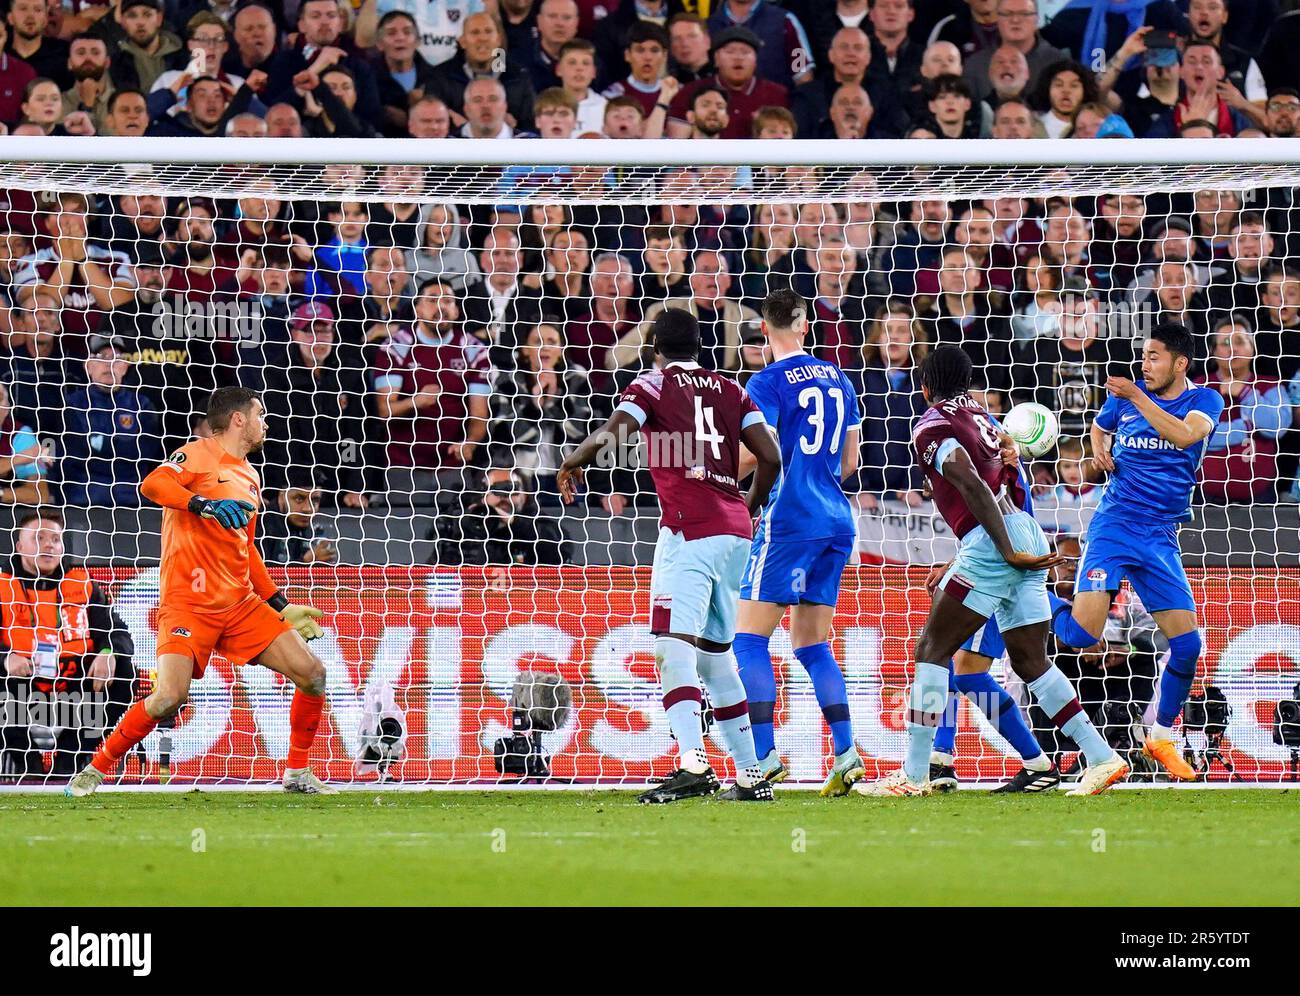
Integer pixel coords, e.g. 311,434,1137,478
490,322,593,506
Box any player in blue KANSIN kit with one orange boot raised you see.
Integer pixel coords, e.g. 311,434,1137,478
1050,322,1223,780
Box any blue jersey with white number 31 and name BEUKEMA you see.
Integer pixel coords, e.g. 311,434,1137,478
745,354,862,540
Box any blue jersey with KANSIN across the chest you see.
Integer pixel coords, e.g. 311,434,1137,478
1097,384,1223,523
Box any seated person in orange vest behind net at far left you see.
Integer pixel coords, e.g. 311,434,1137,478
0,514,135,781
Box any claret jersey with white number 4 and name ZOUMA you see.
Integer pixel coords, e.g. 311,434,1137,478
619,360,763,540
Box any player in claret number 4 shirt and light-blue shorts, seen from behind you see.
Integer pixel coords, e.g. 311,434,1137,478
556,308,781,802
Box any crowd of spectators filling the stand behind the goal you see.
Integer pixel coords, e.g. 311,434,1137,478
0,0,1300,563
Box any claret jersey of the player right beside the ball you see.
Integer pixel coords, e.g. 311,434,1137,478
911,394,1027,538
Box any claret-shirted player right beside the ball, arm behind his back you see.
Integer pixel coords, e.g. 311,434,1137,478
854,346,1128,796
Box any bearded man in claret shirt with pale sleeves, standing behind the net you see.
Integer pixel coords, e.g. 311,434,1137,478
372,278,491,501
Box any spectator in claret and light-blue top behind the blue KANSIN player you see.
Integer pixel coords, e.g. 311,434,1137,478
1196,316,1291,503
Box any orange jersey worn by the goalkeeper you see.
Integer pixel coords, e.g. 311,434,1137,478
140,438,277,612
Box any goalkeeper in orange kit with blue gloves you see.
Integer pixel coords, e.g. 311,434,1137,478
66,387,337,796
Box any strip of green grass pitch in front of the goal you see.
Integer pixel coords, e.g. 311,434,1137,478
0,791,1300,906
